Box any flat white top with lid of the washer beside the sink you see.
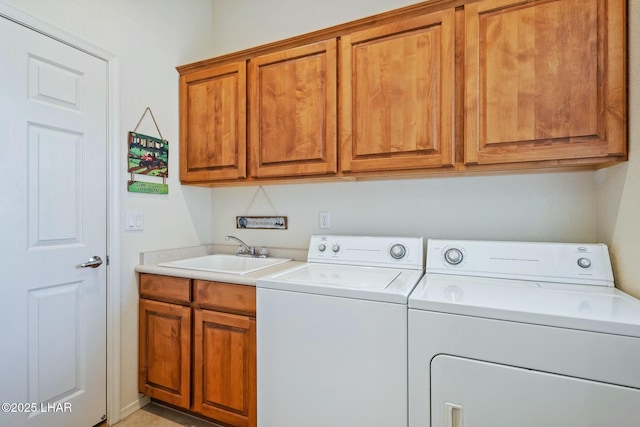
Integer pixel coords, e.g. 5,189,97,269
256,263,423,304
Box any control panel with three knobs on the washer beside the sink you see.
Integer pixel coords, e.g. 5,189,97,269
307,235,424,270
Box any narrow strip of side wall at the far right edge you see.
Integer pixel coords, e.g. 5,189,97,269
596,1,640,298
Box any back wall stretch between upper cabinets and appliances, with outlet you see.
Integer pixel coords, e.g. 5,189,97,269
212,172,596,248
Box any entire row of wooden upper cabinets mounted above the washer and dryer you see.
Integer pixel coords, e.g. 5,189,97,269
178,0,628,185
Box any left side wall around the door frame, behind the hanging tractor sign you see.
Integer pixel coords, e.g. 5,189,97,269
0,0,218,418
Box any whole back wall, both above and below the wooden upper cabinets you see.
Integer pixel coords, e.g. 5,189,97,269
212,0,608,272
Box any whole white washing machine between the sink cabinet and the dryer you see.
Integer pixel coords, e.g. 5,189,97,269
257,236,424,427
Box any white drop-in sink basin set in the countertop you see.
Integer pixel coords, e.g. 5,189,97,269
158,254,291,275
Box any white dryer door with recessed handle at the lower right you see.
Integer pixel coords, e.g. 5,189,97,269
431,355,640,427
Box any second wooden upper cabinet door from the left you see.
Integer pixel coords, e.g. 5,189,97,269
249,39,337,178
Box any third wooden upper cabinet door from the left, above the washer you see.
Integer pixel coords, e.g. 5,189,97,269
340,9,455,172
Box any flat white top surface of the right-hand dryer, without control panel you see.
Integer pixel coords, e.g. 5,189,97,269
409,273,640,337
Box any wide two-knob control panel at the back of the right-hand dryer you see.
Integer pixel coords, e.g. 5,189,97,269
426,239,613,286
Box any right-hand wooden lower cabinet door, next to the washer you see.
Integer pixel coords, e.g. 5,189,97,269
192,309,256,427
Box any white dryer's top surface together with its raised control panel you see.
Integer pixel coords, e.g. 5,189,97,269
409,240,640,337
